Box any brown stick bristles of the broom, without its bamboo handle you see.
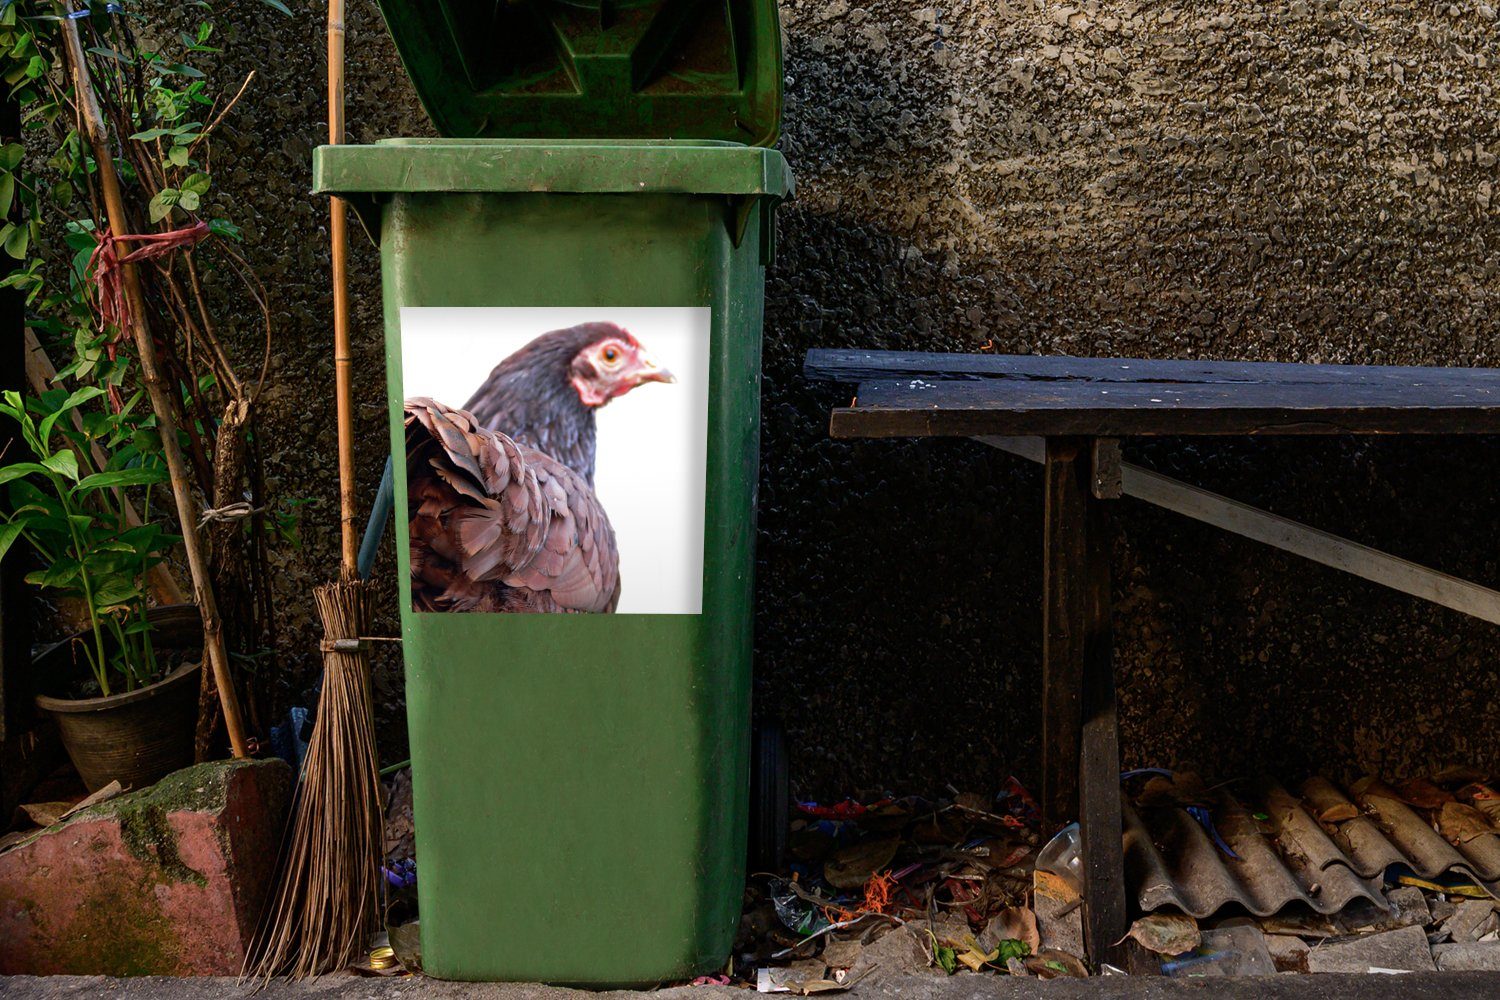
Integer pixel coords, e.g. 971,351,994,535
243,580,384,979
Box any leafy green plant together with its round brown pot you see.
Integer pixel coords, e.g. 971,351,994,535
0,385,203,790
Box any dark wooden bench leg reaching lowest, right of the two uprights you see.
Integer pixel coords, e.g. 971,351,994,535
1079,498,1127,964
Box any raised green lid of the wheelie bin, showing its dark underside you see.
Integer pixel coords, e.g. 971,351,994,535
380,0,782,145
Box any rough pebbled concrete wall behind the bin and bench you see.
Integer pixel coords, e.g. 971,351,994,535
202,0,1500,795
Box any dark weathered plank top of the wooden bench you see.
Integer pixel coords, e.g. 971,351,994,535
804,351,1500,438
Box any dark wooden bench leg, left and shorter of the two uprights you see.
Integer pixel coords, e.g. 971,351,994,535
1041,438,1088,837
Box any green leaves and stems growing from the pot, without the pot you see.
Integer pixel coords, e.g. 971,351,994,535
0,385,179,694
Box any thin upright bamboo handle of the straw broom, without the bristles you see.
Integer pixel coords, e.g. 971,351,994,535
329,0,359,580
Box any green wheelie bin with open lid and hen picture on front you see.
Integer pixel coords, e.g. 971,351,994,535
314,0,792,987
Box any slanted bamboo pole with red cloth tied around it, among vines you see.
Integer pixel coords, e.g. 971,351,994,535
62,0,248,757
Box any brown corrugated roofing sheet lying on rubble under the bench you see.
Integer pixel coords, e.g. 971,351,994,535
1125,778,1500,919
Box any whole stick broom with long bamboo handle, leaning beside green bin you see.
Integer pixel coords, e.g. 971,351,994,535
248,0,384,978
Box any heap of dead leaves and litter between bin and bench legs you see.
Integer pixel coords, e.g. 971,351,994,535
735,778,1050,993
